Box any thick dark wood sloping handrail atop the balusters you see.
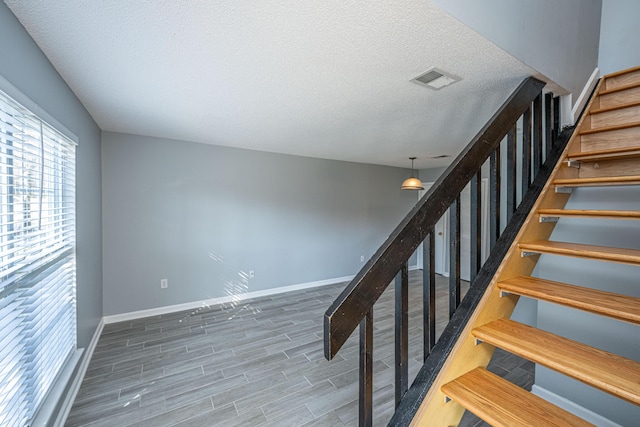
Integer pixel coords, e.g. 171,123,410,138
324,77,545,360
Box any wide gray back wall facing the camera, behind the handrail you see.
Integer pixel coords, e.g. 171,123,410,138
102,132,416,315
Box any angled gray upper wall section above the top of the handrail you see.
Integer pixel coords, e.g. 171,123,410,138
434,0,600,103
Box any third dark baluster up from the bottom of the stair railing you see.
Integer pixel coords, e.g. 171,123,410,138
422,228,436,360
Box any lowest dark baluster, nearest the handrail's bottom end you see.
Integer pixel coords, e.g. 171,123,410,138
359,310,373,427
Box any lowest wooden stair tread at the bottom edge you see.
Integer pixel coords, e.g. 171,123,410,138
442,368,592,427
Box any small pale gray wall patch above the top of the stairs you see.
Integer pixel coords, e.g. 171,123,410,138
598,0,640,74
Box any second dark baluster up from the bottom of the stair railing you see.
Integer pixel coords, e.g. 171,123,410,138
395,263,409,408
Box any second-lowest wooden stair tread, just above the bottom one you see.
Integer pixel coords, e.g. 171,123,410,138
472,319,640,405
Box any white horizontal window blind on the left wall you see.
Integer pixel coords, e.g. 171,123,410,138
0,91,76,427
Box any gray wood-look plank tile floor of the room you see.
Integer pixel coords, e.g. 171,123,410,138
65,271,533,427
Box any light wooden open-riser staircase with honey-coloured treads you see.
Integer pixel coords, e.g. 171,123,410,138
412,67,640,427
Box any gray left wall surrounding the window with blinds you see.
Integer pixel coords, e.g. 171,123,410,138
0,2,102,347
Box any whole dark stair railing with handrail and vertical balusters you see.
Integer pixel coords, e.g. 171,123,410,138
324,77,560,426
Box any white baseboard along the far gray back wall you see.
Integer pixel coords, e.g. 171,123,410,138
103,276,354,325
